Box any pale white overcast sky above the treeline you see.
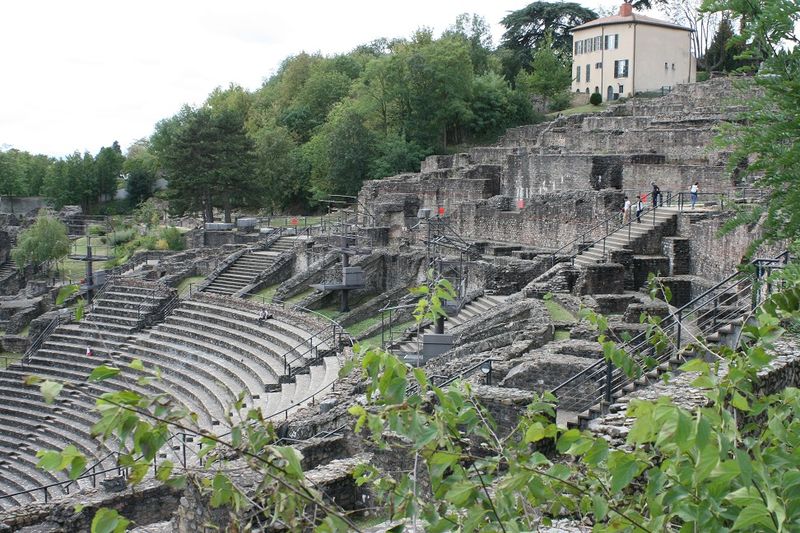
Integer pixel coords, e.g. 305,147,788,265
0,0,636,157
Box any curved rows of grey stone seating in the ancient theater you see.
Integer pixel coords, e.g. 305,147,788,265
0,282,340,510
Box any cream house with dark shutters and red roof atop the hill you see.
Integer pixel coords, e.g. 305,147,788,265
571,2,697,101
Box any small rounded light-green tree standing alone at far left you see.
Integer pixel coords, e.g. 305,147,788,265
11,211,69,269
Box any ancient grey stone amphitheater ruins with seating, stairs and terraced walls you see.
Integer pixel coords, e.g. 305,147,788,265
0,79,797,531
